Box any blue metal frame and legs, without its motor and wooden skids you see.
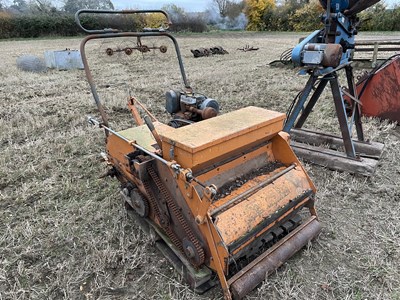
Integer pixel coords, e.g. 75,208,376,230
283,0,379,158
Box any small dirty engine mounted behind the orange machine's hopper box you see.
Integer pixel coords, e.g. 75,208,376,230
165,90,219,128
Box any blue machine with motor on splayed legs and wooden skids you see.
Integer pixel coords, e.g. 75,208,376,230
284,0,383,176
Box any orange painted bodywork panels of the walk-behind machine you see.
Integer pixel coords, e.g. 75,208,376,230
107,107,316,299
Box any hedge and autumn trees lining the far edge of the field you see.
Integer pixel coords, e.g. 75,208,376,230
0,0,400,38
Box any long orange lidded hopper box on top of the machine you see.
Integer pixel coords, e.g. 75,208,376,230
156,106,285,168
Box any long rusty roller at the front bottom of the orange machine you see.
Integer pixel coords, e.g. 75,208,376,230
228,216,321,300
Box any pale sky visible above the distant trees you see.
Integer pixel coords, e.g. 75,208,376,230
112,0,400,12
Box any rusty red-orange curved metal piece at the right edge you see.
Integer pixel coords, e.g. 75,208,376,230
357,56,400,123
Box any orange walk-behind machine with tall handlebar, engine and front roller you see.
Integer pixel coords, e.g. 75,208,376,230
77,11,321,299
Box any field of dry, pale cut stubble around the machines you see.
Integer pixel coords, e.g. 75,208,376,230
0,33,400,300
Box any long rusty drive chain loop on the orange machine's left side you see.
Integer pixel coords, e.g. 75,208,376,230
143,164,205,267
